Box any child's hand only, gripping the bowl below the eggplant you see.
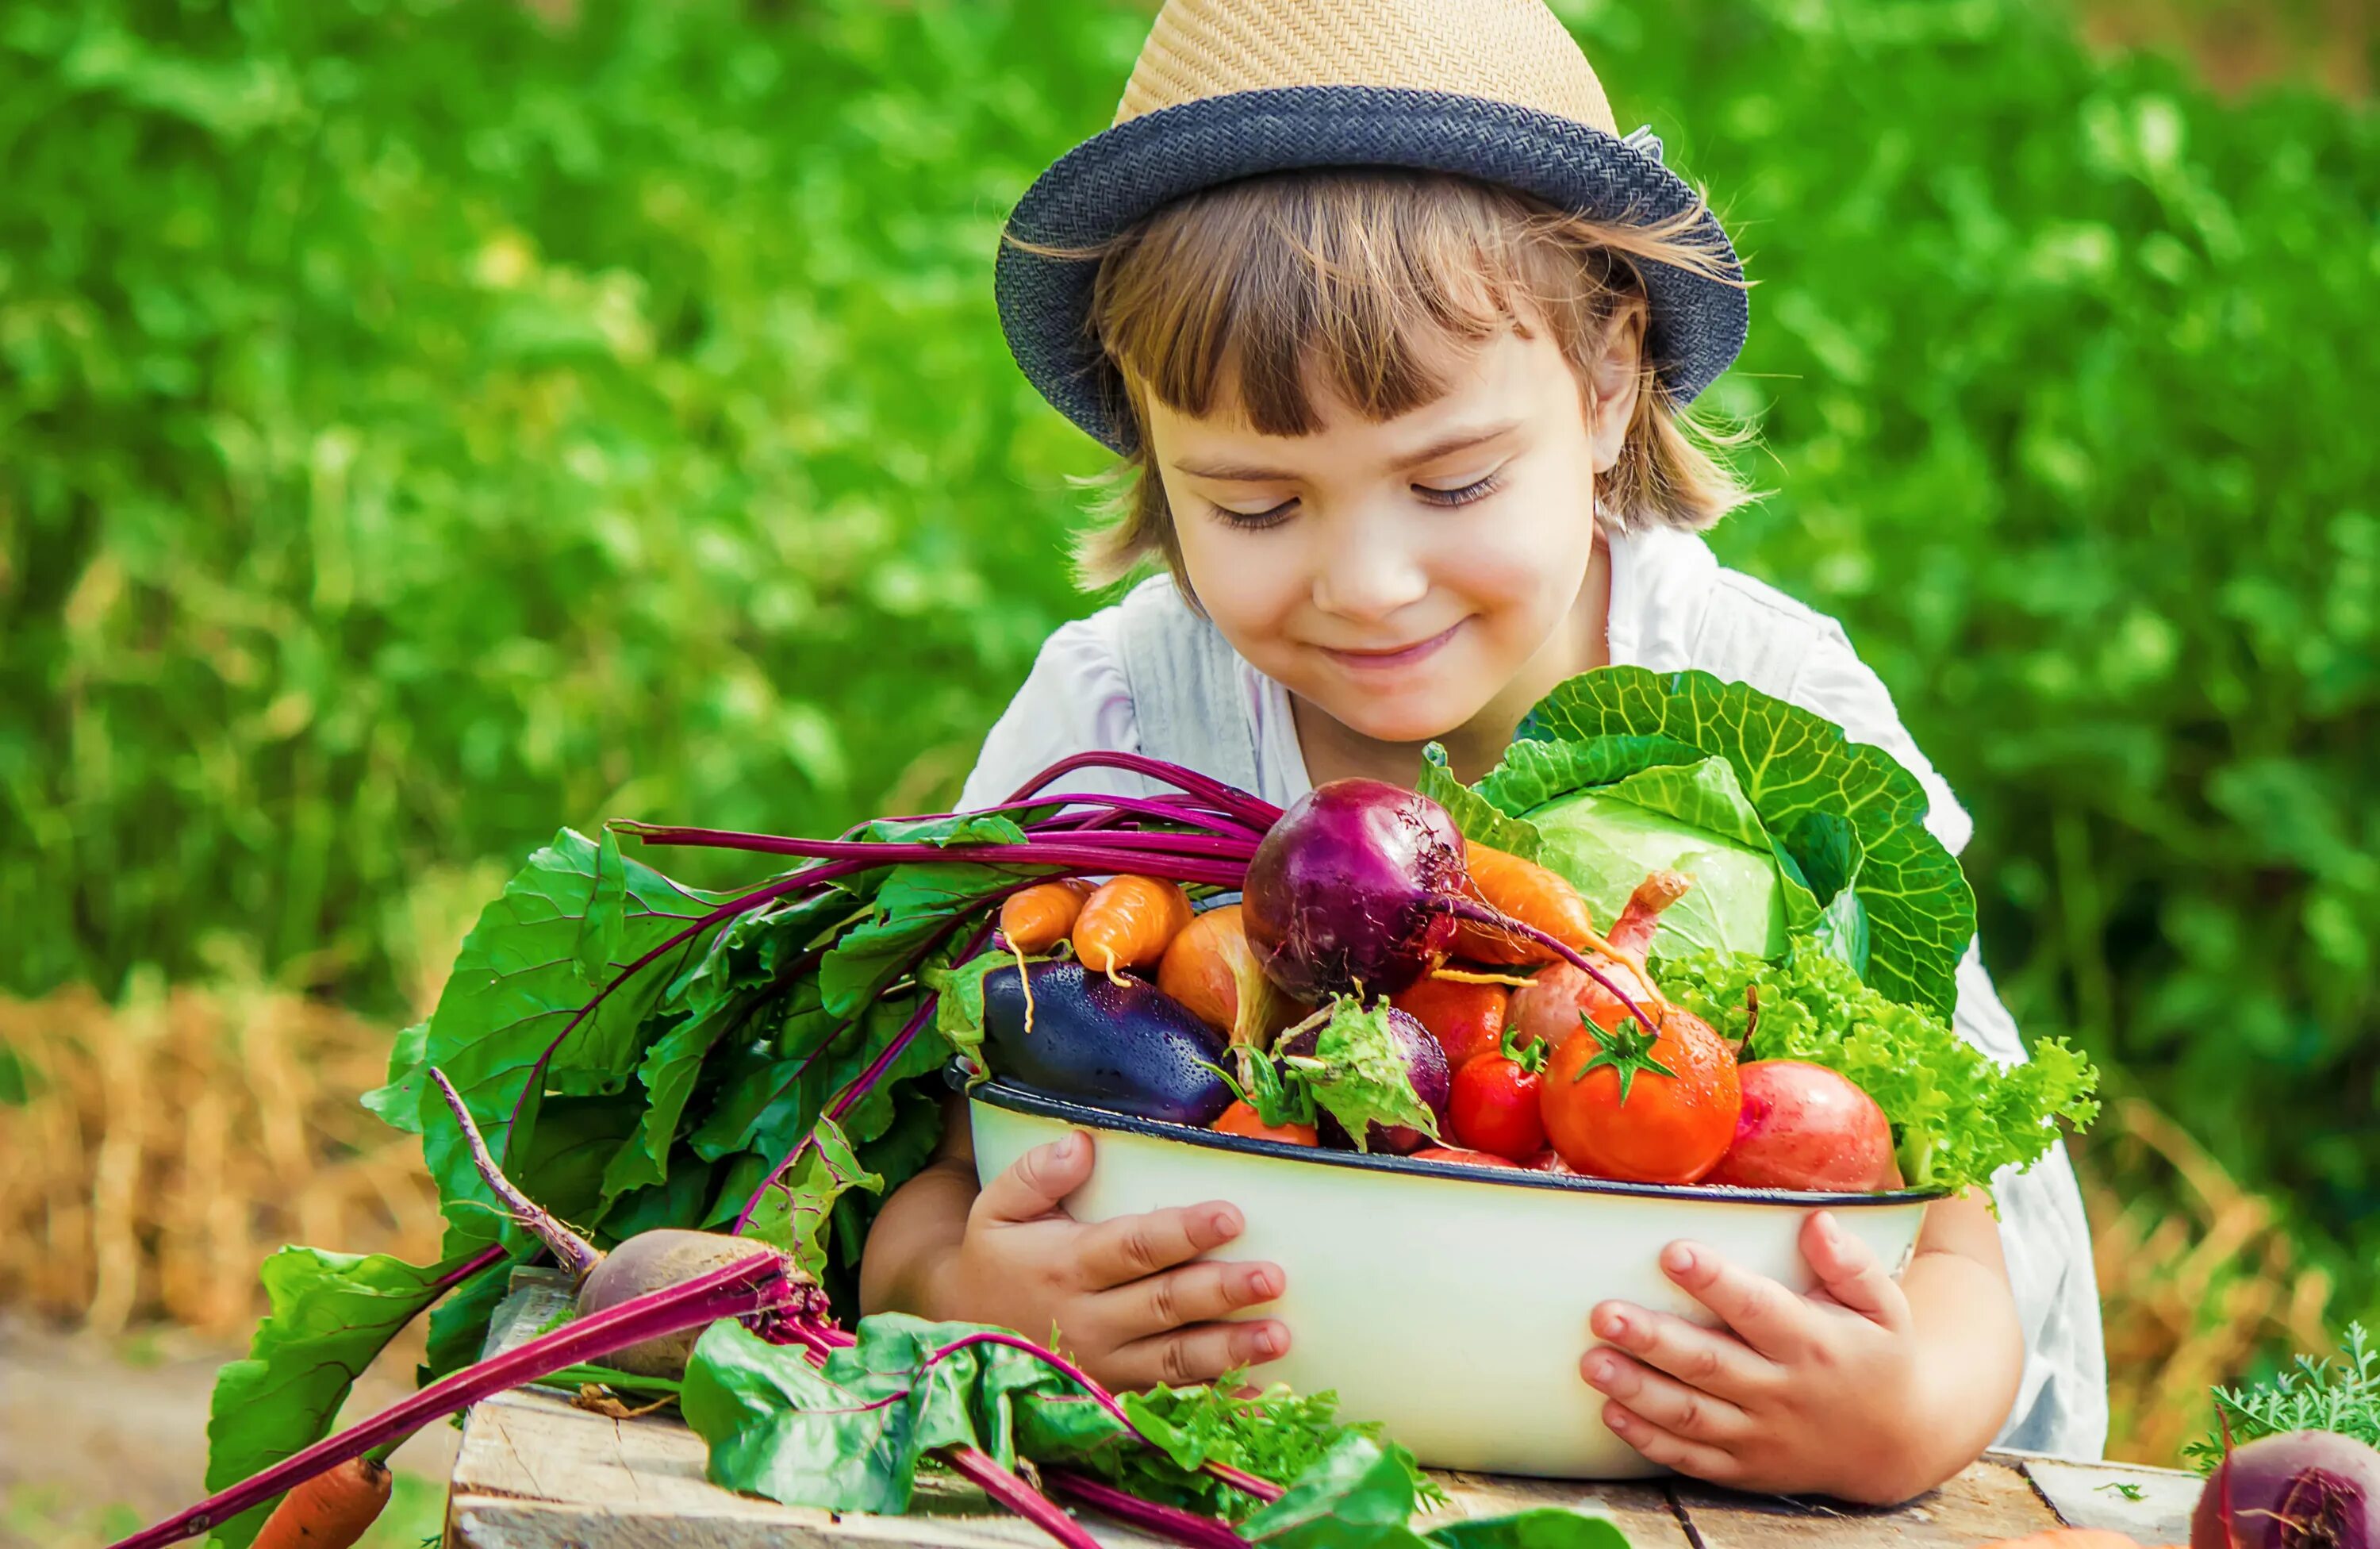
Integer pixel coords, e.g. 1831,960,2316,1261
933,1130,1290,1387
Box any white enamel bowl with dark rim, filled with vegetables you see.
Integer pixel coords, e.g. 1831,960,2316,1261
969,1080,1933,1480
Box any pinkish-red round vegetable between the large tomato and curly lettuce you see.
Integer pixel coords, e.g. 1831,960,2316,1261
1704,1059,1902,1194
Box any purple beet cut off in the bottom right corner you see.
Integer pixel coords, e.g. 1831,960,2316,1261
2190,1430,2380,1549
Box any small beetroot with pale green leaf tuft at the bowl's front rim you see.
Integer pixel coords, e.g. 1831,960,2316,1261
1276,1001,1454,1156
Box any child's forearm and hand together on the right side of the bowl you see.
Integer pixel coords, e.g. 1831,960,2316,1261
1580,1194,2025,1506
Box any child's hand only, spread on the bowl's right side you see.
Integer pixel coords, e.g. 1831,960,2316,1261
1580,1211,1952,1504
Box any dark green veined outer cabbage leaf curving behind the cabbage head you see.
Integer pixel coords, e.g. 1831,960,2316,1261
1514,667,1975,1016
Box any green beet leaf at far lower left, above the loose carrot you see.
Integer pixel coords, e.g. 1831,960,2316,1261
207,1247,462,1549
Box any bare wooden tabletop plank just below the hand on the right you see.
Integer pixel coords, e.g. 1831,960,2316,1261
1671,1456,2061,1549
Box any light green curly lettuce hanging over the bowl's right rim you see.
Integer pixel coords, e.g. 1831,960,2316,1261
1654,937,2099,1194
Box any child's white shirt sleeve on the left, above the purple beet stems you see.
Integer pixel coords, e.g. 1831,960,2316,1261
959,609,1150,811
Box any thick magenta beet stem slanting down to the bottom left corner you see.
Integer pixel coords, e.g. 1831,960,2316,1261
112,1251,797,1549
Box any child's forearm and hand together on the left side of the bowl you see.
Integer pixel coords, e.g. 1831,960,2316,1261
859,1104,1290,1387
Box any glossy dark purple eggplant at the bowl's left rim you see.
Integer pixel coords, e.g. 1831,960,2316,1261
983,961,1233,1128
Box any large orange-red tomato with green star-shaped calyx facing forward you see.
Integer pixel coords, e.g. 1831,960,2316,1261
1537,1001,1745,1182
